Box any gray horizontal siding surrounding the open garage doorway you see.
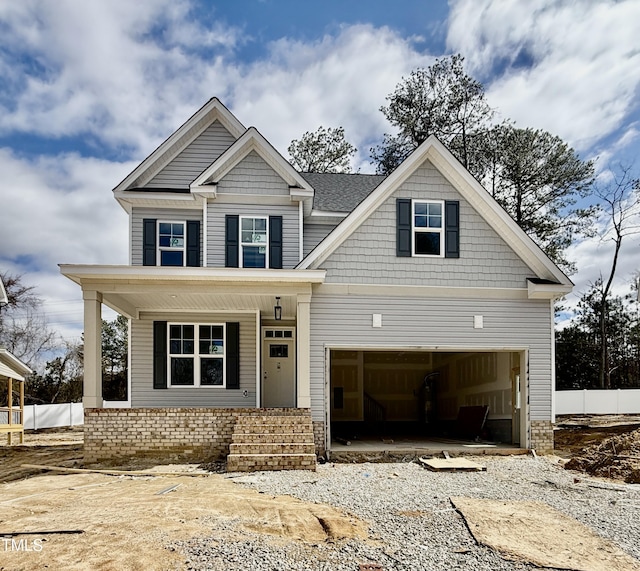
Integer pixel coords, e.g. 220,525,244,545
310,294,553,420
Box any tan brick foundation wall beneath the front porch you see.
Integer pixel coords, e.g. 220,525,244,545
84,408,314,464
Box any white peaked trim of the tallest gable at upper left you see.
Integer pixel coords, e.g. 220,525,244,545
113,97,246,192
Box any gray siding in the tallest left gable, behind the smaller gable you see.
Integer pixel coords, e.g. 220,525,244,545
145,121,235,189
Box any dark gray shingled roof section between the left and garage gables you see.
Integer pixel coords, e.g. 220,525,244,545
300,172,386,212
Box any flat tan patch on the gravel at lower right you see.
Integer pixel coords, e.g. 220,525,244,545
451,497,640,571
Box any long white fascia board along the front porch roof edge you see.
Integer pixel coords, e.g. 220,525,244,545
59,264,326,284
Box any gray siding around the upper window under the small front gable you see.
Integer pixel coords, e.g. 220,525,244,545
207,201,300,269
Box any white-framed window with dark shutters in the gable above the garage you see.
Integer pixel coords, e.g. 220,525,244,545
396,198,460,258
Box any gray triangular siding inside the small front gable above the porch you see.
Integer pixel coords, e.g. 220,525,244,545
217,151,289,196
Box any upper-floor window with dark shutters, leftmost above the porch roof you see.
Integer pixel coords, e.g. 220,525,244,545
142,218,201,267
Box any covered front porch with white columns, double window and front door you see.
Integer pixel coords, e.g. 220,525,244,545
61,265,324,409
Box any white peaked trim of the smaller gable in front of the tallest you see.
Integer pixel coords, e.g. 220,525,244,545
191,127,313,198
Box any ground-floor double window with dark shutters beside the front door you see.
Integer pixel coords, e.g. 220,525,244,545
153,321,240,389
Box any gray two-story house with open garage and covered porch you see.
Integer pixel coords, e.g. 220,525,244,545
61,98,572,459
